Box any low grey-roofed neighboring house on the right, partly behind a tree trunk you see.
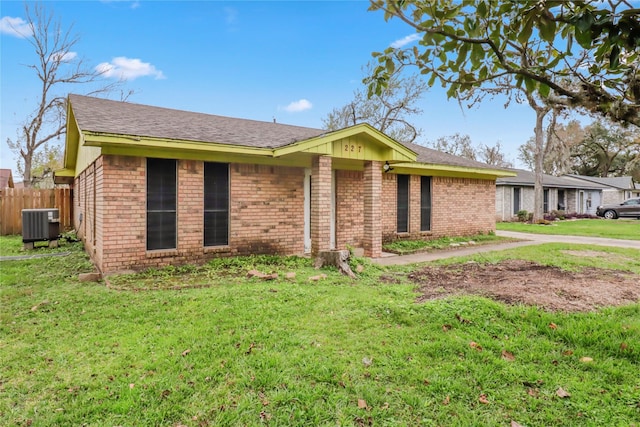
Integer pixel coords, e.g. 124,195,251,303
496,169,606,221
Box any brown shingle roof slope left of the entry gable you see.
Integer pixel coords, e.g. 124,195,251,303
69,95,326,148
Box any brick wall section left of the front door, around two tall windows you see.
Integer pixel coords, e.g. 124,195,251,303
79,155,304,272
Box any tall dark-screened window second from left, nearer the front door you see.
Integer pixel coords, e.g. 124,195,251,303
204,162,229,246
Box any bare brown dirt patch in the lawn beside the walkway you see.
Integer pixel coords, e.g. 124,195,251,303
409,260,640,311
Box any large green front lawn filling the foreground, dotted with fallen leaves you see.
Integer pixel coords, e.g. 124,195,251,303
0,238,640,426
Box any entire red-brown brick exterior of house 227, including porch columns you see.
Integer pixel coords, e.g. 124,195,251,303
74,155,495,272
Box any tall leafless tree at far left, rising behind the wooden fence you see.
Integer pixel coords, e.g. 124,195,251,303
7,3,121,187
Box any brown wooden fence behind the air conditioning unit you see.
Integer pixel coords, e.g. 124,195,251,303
0,188,73,236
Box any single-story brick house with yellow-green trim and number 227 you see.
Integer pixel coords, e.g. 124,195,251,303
55,95,513,273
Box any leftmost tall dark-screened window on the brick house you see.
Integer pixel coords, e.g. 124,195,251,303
147,159,177,250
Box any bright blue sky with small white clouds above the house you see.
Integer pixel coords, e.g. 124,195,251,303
0,0,534,177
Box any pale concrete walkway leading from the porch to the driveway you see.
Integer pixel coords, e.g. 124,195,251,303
372,230,640,265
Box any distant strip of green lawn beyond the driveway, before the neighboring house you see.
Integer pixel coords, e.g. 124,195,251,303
496,219,640,240
